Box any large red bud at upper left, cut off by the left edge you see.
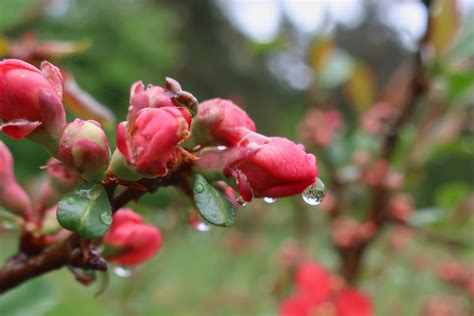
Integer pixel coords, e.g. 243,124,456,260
0,59,66,144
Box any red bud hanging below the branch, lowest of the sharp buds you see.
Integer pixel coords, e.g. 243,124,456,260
104,208,162,265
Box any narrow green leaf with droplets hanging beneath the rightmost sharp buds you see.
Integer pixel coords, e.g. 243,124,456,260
194,174,237,226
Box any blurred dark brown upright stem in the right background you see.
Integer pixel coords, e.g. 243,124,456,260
339,0,431,282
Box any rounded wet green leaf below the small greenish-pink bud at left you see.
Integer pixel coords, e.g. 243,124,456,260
57,182,112,239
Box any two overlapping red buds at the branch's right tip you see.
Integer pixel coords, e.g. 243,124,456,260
193,98,318,201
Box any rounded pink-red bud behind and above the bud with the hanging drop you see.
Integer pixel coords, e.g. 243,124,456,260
193,98,256,146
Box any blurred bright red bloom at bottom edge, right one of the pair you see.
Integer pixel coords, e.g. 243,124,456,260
334,288,373,316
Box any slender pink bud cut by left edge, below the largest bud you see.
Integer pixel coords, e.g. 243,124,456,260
0,141,31,217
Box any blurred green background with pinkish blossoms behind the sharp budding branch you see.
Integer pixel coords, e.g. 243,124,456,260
0,0,474,316
